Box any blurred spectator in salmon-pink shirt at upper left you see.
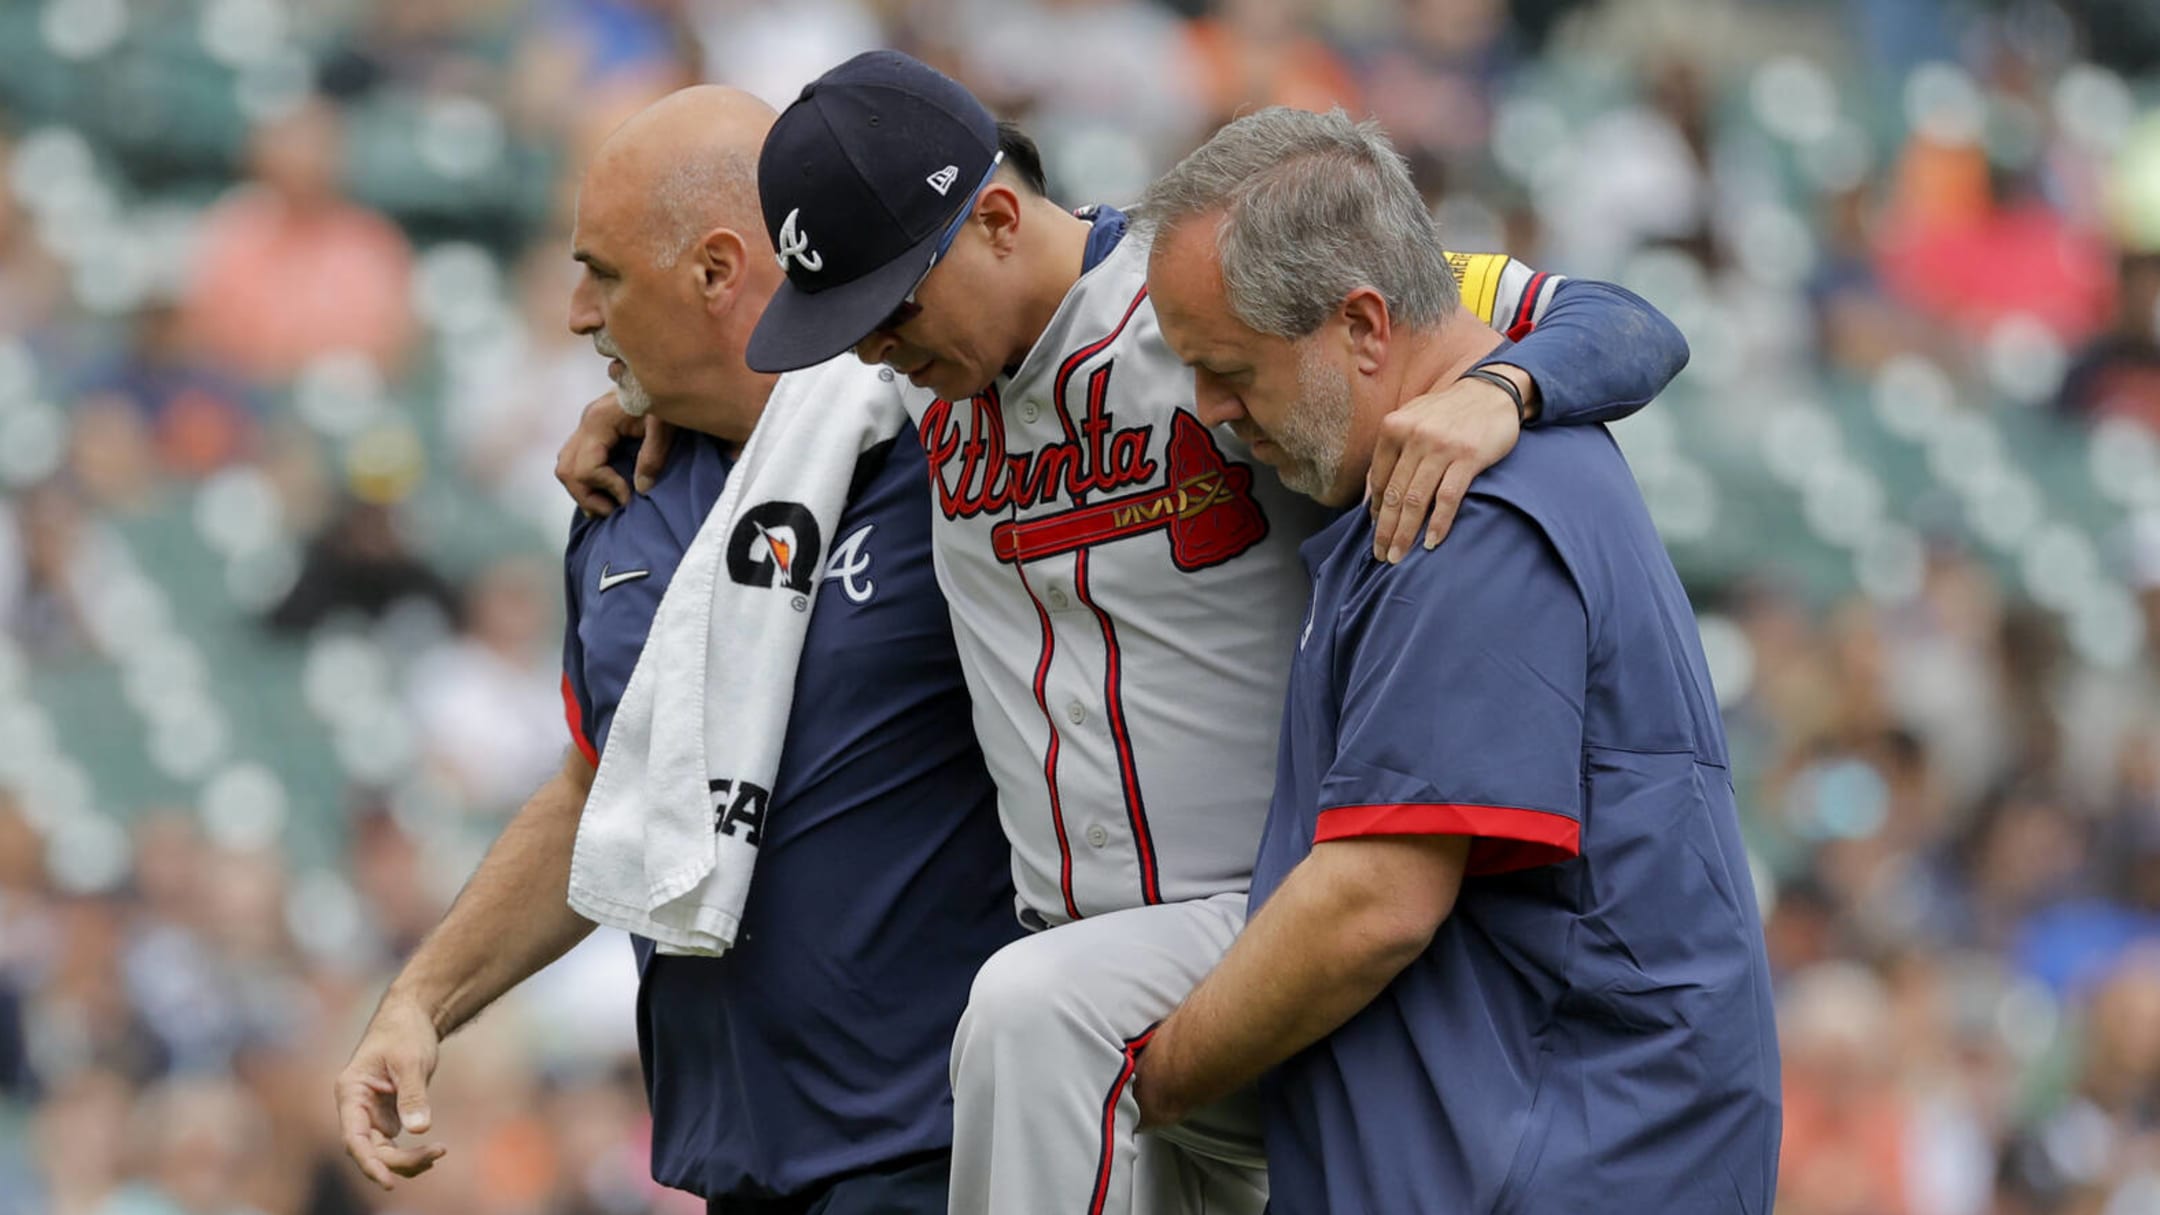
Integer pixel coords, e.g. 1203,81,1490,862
181,99,415,383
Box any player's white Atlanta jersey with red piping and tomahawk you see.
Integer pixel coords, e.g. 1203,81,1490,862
909,208,1562,923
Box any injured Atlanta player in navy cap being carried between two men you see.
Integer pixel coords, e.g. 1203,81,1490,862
564,52,1687,1213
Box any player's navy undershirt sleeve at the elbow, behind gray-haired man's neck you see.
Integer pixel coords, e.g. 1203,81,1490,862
1484,279,1687,426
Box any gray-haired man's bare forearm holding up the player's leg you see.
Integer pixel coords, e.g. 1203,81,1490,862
1140,841,1467,1111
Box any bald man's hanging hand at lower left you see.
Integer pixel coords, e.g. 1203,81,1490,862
337,1001,449,1189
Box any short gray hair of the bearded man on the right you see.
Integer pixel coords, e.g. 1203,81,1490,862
1136,106,1460,337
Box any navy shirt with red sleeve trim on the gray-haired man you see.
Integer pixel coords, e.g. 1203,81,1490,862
1253,426,1780,1215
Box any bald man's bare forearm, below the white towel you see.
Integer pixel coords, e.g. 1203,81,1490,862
382,750,592,1038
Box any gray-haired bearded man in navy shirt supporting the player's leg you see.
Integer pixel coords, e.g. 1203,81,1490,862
1136,108,1778,1215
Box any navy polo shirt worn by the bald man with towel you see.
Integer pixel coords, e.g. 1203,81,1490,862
564,412,1020,1198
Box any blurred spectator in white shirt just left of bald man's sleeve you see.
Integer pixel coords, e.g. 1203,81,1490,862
410,560,562,815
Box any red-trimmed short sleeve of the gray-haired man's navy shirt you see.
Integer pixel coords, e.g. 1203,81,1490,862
1313,493,1590,873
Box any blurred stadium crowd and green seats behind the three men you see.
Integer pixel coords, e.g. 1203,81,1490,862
0,0,2160,1215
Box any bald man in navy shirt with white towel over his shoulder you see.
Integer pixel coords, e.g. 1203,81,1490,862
337,86,1020,1215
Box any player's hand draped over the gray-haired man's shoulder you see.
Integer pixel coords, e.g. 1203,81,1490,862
1365,363,1536,562
